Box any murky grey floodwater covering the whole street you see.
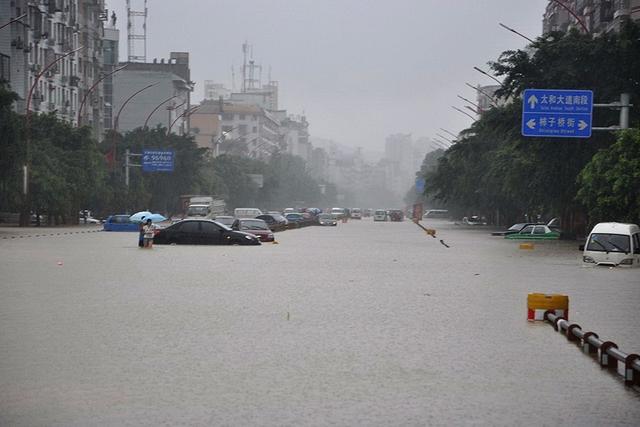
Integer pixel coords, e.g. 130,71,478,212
0,219,640,426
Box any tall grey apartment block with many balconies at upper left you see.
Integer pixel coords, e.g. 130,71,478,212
0,0,107,137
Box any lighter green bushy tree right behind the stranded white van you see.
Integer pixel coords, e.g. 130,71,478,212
578,129,640,223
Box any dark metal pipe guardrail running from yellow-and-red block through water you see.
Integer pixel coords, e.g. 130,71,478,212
544,310,640,386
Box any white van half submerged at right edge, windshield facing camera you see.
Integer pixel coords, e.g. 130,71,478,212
582,222,640,267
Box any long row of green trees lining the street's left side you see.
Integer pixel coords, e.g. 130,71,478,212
0,84,336,224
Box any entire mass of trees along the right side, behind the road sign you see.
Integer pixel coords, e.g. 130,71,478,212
418,23,640,234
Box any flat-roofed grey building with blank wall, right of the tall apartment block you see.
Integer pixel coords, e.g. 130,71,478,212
113,52,193,135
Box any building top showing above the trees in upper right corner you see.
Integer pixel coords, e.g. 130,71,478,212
542,0,640,34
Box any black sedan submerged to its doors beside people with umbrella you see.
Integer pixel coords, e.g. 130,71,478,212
153,219,260,245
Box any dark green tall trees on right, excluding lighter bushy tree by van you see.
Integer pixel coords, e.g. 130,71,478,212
423,24,640,228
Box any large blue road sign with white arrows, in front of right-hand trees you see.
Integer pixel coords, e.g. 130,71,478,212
522,89,593,138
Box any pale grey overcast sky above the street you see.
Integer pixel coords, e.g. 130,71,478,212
107,0,548,150
